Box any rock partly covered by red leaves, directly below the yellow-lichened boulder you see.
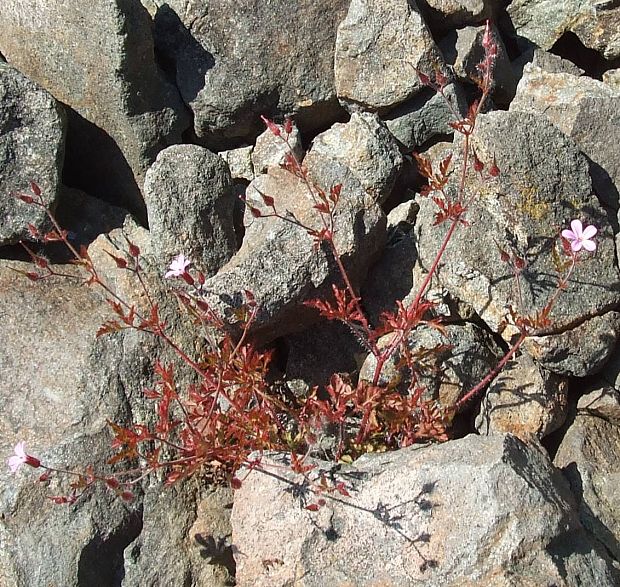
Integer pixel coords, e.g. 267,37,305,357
359,323,503,408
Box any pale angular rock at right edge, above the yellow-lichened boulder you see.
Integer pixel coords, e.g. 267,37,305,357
510,65,620,209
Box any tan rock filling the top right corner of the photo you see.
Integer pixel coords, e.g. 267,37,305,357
507,0,620,60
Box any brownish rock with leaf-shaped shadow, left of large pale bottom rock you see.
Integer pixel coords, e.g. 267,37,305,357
122,478,234,587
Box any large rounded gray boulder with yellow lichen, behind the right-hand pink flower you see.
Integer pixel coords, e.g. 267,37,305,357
415,112,620,340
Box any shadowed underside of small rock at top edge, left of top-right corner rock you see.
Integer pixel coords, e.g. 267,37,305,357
416,0,503,32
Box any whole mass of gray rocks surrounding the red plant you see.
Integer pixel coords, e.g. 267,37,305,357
0,0,620,587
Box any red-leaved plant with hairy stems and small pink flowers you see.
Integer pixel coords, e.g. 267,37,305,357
4,21,596,509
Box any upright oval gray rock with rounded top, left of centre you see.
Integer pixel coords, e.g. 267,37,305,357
144,145,236,276
